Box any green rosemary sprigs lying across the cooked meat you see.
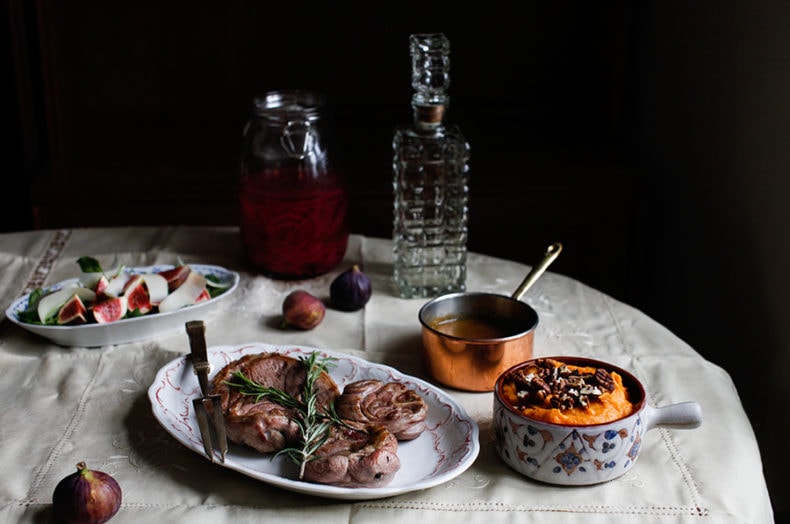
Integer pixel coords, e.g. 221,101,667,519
226,352,343,479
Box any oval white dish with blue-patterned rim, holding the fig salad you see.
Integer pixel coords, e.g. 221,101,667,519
5,264,239,347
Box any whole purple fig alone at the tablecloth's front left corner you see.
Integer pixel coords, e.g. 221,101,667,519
52,462,121,524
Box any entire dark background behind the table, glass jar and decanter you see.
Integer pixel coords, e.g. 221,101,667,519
0,0,790,515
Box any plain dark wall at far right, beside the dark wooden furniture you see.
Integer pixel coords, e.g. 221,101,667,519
631,1,790,522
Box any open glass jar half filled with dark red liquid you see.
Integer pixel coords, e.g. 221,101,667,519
239,90,349,280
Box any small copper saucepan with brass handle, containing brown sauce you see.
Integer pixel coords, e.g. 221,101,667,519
418,243,562,391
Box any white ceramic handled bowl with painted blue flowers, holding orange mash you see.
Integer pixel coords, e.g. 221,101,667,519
493,356,702,486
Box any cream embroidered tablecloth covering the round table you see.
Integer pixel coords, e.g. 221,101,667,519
0,227,773,524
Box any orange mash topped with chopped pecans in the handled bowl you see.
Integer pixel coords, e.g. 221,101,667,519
502,358,635,425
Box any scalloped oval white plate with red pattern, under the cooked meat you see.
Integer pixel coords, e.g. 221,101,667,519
148,343,480,500
